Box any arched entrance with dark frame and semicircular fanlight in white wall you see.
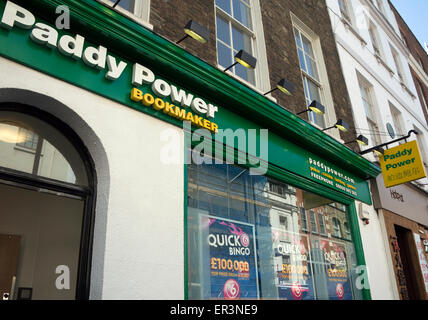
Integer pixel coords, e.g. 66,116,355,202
0,103,96,299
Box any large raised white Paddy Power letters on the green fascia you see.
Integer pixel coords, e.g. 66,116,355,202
0,1,218,121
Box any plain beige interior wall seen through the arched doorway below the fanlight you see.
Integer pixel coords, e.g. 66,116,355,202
0,184,83,300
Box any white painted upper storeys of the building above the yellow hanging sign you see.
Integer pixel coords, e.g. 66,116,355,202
326,0,428,180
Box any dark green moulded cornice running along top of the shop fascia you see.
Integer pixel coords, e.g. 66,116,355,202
11,0,381,179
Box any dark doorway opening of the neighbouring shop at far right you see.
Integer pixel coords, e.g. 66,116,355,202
395,225,424,300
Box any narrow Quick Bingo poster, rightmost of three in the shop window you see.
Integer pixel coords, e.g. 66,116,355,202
321,240,352,300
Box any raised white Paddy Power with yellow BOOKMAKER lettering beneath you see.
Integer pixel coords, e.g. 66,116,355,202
0,1,218,133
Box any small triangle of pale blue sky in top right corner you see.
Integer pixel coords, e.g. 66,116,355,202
391,0,428,49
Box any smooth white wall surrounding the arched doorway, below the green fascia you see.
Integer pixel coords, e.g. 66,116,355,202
0,58,184,299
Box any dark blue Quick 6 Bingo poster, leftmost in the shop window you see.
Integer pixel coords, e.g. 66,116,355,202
201,216,259,300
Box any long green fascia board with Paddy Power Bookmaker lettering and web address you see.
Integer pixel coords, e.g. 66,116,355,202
0,0,371,204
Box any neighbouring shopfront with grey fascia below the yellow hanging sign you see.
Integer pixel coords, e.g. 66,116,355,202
372,176,428,300
